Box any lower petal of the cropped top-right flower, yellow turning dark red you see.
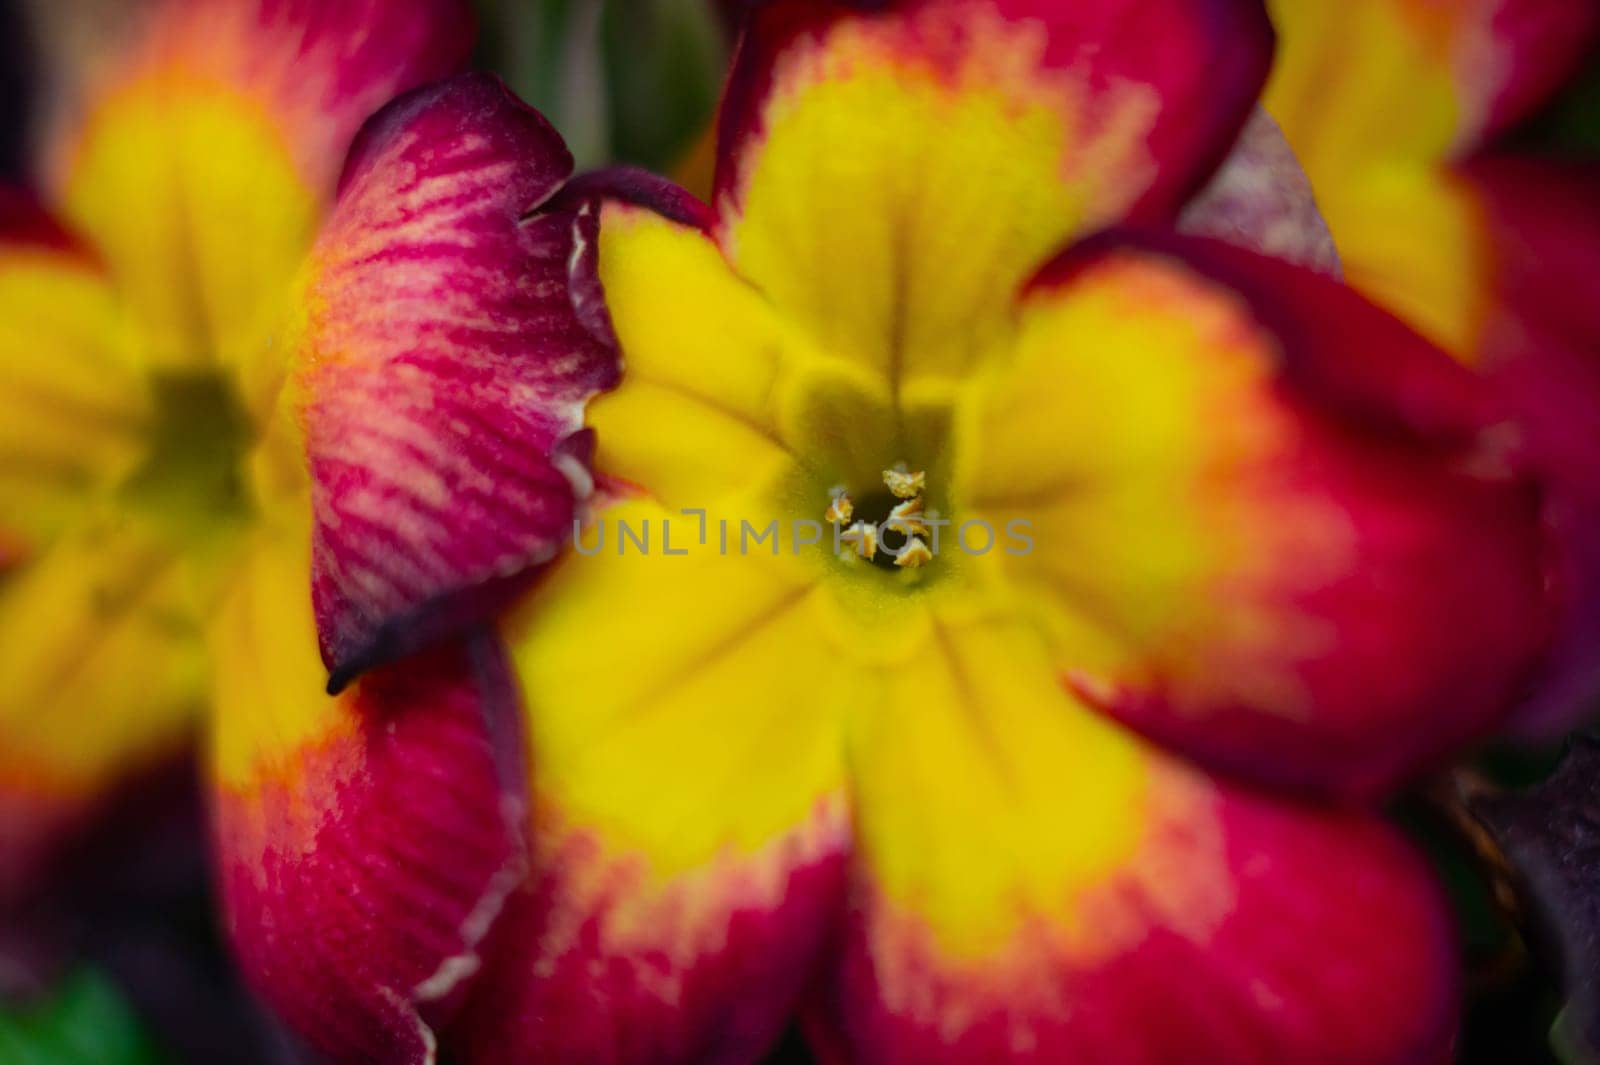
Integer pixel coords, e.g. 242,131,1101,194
1209,157,1600,734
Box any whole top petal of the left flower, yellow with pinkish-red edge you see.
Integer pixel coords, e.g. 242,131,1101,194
45,0,472,398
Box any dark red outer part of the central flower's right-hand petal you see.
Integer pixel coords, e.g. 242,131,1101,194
1016,232,1555,800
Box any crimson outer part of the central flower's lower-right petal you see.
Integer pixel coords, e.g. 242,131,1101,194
808,770,1459,1065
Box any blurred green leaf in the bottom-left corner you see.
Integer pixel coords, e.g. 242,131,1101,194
0,969,165,1065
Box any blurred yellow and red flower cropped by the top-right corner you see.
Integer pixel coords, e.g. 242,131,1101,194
1266,0,1600,736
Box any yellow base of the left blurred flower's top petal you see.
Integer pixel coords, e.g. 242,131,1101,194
62,67,320,392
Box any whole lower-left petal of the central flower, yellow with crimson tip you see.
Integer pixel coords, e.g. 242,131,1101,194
458,501,846,1065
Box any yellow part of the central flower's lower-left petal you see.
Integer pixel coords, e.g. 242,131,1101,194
506,489,840,876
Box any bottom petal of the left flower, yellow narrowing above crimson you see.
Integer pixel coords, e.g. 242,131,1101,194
211,511,525,1065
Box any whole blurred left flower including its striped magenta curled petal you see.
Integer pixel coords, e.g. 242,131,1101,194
0,0,616,1060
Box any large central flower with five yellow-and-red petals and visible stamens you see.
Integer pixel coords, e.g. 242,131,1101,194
425,0,1550,1065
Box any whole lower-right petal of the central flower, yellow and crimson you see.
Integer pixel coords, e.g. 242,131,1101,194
813,604,1458,1065
